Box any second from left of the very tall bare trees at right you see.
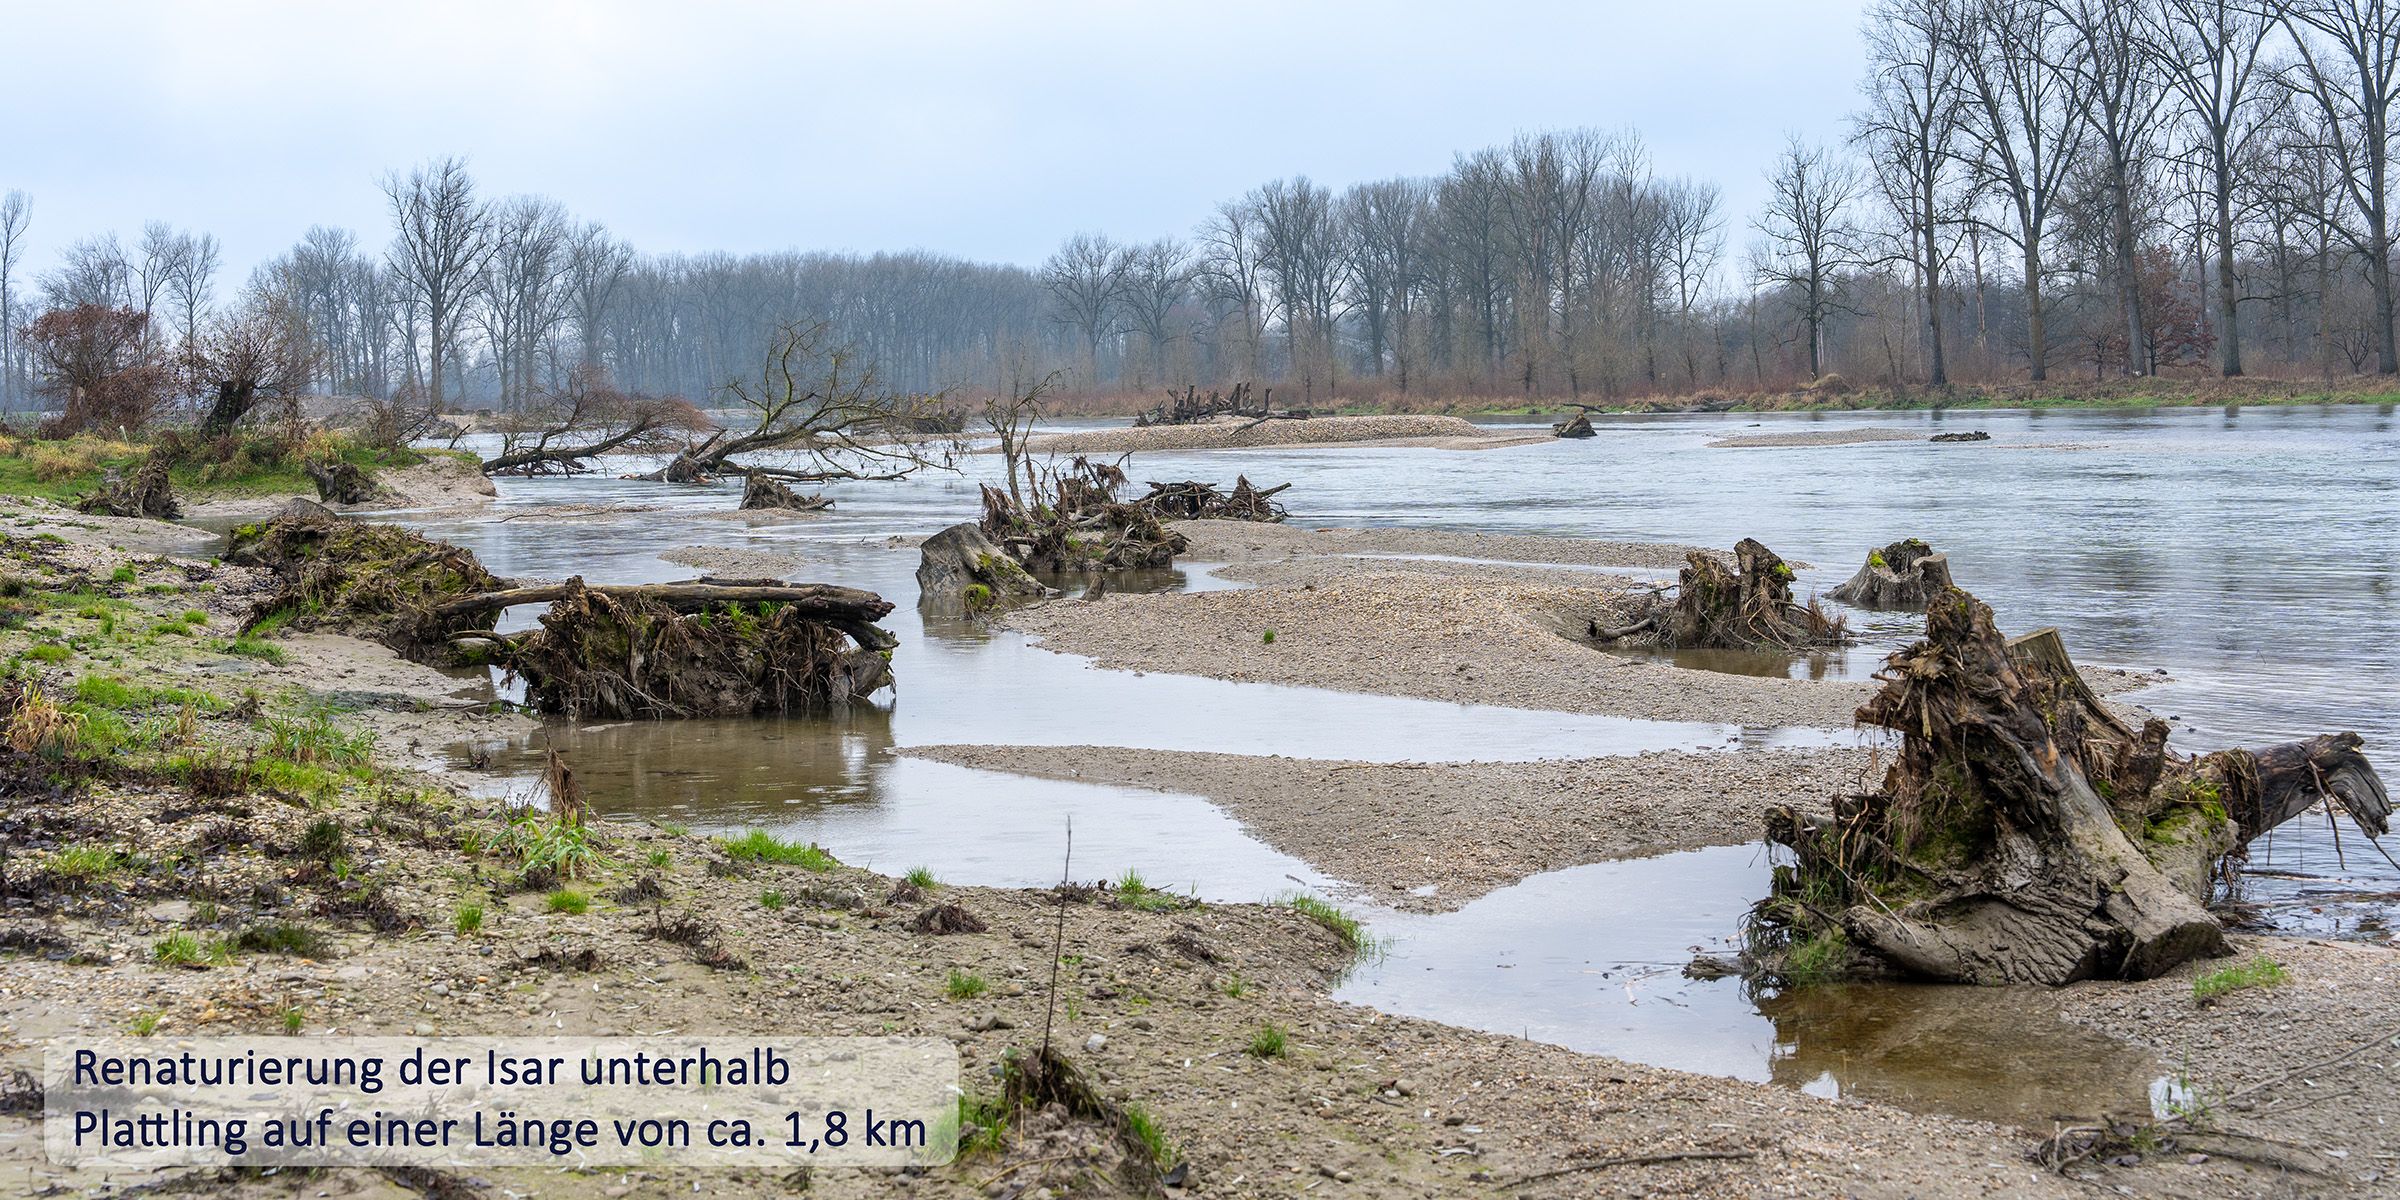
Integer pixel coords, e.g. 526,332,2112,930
1954,0,2088,379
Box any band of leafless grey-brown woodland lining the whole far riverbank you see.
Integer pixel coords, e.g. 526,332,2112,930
0,0,2400,408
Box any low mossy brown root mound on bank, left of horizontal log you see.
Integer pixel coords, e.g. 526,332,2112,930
226,511,506,662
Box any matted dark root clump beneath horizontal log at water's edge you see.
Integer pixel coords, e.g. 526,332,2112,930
509,578,895,720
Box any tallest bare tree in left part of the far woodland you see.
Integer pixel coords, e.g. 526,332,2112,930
384,158,492,415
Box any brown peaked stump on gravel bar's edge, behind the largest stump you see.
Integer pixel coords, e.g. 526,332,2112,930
1591,538,1850,650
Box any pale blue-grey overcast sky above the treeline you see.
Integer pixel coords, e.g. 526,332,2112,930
0,0,1860,283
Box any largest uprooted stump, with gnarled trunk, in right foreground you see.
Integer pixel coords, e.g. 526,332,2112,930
1750,588,2390,984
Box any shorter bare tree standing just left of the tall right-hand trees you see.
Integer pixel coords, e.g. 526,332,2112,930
1757,137,1860,379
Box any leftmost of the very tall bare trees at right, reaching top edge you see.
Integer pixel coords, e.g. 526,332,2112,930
1858,0,1966,386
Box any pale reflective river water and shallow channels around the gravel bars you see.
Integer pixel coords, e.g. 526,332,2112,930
384,408,2400,1126
